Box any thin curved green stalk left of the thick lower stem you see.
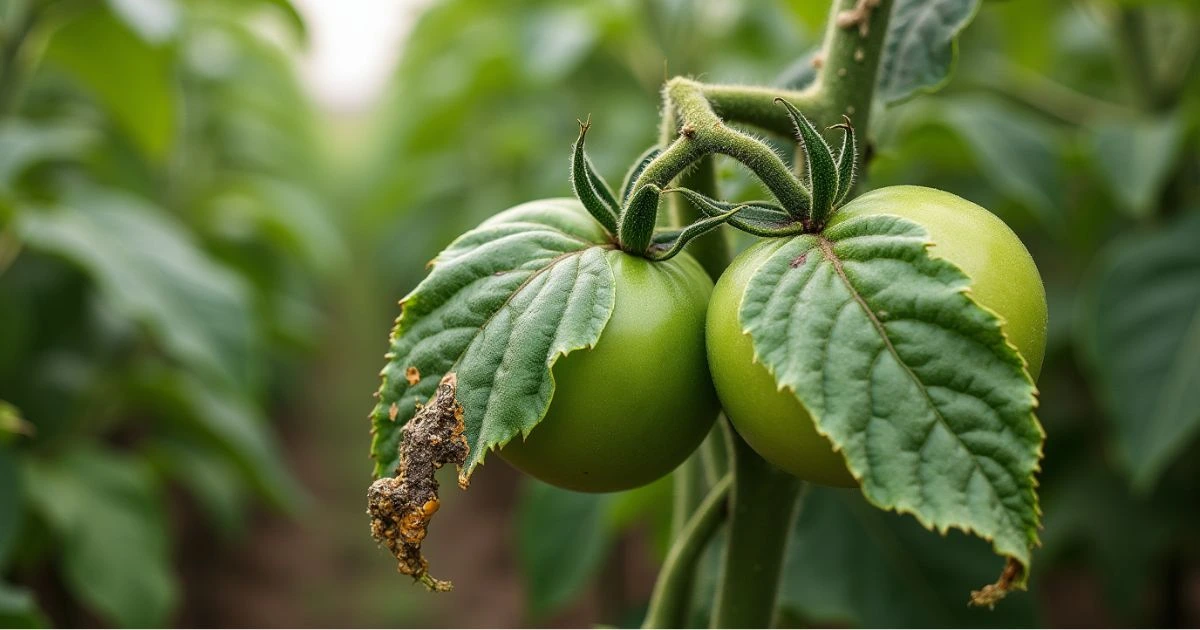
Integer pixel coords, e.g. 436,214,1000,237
642,475,733,628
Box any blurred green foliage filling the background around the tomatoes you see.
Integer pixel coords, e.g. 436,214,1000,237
0,0,1200,626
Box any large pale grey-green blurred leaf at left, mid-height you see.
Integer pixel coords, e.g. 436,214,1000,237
18,187,257,390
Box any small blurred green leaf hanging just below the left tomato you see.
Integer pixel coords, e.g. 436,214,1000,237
516,480,614,618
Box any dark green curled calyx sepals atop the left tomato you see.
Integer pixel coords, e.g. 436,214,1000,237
571,119,748,260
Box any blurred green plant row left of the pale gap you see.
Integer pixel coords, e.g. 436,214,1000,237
0,0,344,625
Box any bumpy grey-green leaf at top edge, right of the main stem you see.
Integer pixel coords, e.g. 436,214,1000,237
876,0,979,104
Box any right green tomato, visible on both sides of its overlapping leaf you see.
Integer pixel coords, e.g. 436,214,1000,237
707,186,1046,487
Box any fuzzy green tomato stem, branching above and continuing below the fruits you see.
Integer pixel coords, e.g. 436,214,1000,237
632,0,893,628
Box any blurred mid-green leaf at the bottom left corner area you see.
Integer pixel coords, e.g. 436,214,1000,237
25,449,179,626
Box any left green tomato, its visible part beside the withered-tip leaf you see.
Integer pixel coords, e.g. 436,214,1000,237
499,251,719,492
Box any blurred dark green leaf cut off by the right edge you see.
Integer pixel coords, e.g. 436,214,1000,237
1079,214,1200,490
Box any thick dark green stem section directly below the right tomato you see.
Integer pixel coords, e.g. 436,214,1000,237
710,430,803,628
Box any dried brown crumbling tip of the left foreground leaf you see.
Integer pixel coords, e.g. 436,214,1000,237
367,372,468,590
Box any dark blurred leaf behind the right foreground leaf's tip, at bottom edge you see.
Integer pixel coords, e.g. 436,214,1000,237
780,486,1037,628
